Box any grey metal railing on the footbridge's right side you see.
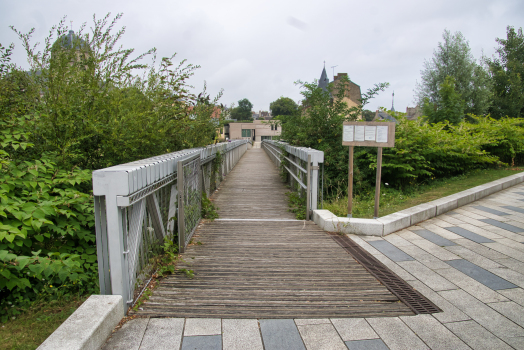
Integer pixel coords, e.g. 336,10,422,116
262,140,324,220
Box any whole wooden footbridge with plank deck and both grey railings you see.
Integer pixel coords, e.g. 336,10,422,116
93,141,435,318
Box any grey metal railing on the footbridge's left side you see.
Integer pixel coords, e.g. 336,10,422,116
93,140,247,309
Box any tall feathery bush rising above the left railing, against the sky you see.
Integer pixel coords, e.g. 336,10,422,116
9,14,220,169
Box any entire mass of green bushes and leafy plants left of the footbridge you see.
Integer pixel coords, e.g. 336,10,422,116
0,14,225,322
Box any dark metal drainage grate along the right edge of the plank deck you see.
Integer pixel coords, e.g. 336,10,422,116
328,233,442,314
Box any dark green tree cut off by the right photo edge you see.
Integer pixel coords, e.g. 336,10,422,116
488,26,524,118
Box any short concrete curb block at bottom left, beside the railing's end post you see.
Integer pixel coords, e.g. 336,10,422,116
38,295,124,350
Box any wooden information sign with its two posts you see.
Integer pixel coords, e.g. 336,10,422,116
342,122,395,218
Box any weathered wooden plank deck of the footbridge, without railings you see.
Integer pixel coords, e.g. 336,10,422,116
138,149,413,318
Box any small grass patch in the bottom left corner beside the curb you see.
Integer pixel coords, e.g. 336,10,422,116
0,295,89,350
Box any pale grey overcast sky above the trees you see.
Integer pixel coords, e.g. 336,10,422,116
0,0,524,111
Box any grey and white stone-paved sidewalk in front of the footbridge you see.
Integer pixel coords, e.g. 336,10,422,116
103,184,524,350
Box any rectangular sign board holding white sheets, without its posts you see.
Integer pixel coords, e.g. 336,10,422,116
342,122,395,147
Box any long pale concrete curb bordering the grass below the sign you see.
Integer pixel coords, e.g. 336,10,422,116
313,172,524,236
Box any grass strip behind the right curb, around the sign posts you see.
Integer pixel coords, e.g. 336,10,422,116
324,168,524,219
